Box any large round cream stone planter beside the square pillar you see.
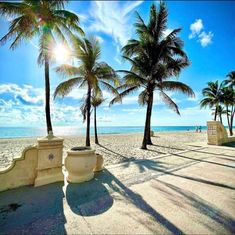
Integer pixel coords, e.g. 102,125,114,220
65,147,96,183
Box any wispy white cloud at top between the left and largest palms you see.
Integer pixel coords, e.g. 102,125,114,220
88,1,143,46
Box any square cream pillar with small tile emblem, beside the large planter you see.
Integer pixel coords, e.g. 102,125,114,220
34,134,64,186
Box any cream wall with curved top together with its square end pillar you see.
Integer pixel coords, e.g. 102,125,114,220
0,135,64,191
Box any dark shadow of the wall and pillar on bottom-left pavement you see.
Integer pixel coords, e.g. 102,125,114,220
0,182,67,234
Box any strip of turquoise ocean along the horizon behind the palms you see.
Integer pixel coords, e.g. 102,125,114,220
0,126,207,138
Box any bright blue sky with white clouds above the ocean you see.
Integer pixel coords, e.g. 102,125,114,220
0,1,235,126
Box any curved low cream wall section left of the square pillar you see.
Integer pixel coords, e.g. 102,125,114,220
0,146,38,191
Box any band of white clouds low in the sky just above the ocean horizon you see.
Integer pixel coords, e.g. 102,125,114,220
0,83,208,127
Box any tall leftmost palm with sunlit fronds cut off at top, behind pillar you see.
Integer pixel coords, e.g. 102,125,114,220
0,0,83,133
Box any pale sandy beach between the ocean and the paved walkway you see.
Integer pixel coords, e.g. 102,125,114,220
0,131,207,170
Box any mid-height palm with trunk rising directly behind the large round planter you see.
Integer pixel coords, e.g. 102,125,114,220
54,38,119,146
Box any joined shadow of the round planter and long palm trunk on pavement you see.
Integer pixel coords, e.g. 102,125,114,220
66,169,183,234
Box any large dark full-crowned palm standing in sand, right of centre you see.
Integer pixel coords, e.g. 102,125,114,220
111,2,194,149
